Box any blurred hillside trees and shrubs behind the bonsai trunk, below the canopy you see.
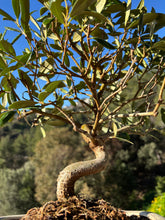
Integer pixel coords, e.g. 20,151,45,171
0,116,165,215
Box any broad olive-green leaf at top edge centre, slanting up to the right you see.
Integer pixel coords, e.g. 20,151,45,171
70,0,97,17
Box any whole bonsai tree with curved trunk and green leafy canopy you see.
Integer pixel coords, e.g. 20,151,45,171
0,0,165,200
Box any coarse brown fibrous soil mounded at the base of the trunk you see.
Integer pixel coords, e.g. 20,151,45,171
21,197,149,220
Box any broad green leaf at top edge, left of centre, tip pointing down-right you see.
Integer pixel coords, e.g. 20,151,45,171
50,0,65,24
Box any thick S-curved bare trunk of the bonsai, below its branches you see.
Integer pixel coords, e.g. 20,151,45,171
57,145,107,200
